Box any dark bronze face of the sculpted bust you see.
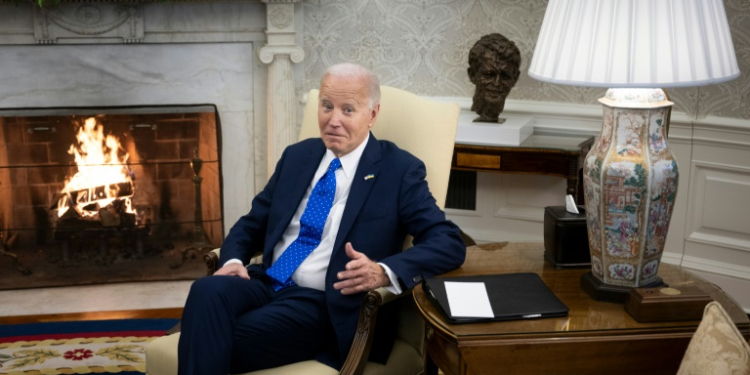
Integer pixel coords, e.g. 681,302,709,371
472,51,518,101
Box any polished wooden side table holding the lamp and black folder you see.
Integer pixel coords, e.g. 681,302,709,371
413,243,750,375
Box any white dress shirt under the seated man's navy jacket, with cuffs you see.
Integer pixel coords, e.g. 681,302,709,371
224,134,401,294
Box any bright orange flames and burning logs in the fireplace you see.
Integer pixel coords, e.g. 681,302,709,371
57,117,135,217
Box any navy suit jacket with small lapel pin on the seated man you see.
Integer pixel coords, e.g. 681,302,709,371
220,134,466,368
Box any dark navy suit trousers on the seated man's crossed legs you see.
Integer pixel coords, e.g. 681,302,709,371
178,274,336,375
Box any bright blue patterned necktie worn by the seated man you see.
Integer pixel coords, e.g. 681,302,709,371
266,158,341,291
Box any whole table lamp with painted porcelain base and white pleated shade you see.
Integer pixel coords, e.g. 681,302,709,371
529,0,739,302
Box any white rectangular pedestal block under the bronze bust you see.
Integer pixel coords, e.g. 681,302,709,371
456,111,534,146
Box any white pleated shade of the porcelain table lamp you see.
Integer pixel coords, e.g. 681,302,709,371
529,0,740,88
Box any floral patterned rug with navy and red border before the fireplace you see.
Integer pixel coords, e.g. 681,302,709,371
0,319,178,375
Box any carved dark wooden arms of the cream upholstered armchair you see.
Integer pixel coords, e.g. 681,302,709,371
203,249,408,375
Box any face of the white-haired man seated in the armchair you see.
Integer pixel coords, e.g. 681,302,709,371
318,76,380,157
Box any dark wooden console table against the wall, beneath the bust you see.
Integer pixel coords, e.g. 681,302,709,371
451,133,594,204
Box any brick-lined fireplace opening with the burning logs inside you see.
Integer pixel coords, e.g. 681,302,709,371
0,105,223,289
